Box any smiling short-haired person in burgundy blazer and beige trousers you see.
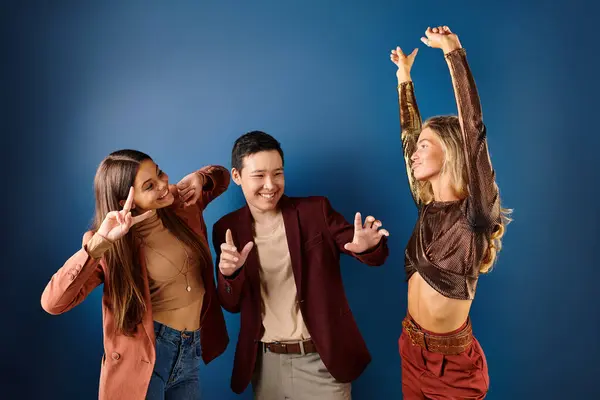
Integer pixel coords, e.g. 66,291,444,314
213,131,389,400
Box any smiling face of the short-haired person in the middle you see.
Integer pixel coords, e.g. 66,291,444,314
231,150,285,213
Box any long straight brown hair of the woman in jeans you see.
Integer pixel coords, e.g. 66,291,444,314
92,150,210,335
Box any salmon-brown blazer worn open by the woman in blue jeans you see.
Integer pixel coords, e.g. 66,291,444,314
42,166,230,400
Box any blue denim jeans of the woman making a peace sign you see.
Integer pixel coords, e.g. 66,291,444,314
146,321,202,400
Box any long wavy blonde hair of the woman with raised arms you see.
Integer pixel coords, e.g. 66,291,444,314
416,115,512,274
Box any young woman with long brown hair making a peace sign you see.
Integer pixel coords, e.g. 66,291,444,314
42,150,230,400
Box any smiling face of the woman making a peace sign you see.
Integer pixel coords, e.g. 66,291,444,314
133,160,175,213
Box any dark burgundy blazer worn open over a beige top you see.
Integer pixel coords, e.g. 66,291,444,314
213,196,388,393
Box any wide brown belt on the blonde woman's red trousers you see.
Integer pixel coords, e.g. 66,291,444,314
402,317,473,355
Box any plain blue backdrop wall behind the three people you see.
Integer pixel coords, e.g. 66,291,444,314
0,0,600,400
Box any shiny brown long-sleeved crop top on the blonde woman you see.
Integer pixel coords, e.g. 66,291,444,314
398,48,500,300
